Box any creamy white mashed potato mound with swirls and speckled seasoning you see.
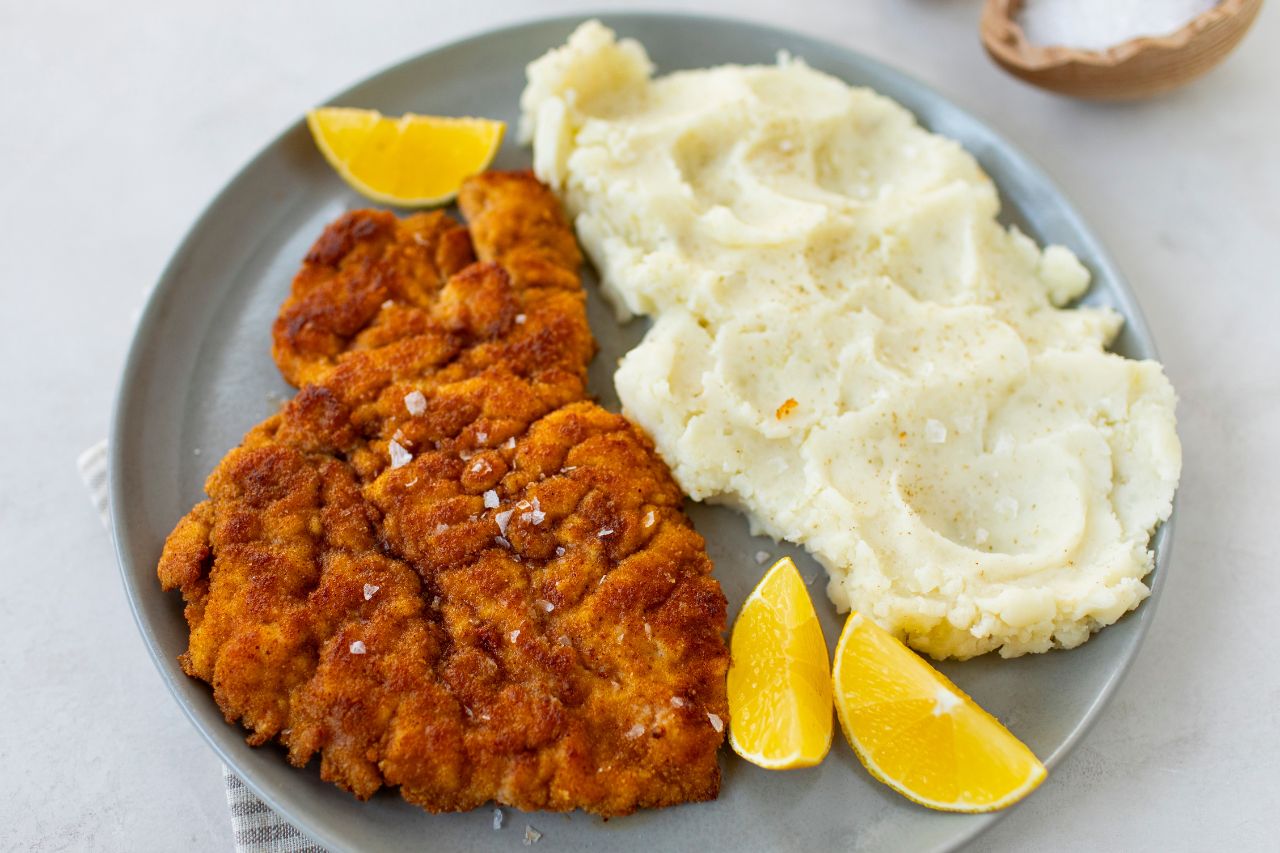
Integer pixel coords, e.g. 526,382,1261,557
521,22,1181,657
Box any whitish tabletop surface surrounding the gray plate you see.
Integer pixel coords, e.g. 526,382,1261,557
0,0,1280,850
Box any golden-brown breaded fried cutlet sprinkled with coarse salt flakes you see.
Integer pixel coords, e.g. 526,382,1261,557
159,173,728,816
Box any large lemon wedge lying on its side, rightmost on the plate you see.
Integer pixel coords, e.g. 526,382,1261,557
832,612,1047,812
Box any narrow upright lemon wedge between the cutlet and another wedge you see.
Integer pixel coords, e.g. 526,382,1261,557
728,557,835,770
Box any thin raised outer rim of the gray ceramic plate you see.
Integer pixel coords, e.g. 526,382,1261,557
108,9,1178,852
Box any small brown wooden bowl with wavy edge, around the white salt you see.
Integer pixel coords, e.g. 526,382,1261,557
980,0,1262,100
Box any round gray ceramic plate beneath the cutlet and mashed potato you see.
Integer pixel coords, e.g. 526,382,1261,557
110,14,1170,853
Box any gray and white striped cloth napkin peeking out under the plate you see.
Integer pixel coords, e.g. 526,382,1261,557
76,441,325,853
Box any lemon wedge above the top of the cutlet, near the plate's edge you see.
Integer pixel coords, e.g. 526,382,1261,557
307,106,507,207
